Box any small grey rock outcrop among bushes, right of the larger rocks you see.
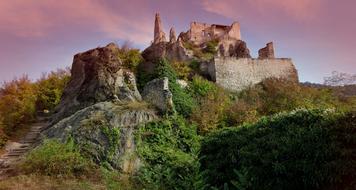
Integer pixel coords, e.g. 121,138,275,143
142,77,173,113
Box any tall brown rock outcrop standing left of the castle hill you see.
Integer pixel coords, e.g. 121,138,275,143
53,44,141,122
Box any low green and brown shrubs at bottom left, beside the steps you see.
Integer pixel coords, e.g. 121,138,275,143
11,140,141,190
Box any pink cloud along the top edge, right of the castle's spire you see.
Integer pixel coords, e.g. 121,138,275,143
202,0,322,22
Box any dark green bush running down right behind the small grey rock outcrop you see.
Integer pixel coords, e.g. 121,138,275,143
154,59,196,117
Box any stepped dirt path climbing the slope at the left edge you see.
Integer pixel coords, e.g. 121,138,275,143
0,119,48,180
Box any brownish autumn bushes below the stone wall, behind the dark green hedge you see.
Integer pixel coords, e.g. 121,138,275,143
224,79,356,126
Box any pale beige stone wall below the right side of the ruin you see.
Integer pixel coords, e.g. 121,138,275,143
207,57,298,92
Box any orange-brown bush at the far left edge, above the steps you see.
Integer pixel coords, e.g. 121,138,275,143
0,76,36,135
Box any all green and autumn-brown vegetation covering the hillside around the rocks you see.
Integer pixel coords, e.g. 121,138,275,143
0,51,356,189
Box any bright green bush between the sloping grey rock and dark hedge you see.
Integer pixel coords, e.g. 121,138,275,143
137,116,201,189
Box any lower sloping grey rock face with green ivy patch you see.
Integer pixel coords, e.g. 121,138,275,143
43,102,157,173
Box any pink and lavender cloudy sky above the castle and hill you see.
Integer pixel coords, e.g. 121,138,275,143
0,0,356,83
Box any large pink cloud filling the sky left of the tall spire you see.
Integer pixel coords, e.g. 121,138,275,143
0,0,152,43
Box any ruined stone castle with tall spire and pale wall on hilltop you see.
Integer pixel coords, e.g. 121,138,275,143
143,14,298,91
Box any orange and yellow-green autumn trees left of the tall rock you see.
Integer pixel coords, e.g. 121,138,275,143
0,69,69,148
